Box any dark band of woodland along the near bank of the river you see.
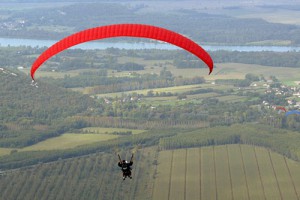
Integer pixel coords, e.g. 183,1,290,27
0,47,300,73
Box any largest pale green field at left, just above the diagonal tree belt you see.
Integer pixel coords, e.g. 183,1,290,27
19,133,118,151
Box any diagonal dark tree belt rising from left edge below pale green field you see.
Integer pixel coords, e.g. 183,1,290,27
0,129,181,170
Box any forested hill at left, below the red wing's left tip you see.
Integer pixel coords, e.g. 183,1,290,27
0,68,96,147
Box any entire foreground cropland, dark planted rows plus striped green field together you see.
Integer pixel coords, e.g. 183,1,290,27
0,145,300,200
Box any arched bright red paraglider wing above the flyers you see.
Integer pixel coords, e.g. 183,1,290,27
30,24,214,80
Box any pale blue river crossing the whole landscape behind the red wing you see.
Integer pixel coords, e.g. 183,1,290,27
0,38,300,52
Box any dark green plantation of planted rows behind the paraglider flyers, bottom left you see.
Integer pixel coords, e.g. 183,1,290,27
0,149,155,200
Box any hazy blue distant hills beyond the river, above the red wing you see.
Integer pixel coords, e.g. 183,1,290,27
0,2,300,45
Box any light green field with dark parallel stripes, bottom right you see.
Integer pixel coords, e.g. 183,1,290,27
153,145,300,200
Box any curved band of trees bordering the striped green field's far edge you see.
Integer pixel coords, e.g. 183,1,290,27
159,124,300,161
